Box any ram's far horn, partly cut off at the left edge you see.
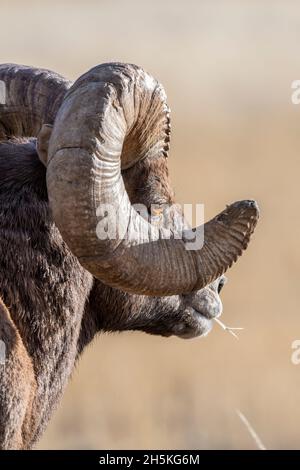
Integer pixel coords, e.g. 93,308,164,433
0,64,71,140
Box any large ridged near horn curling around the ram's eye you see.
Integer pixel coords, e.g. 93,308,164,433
47,63,258,295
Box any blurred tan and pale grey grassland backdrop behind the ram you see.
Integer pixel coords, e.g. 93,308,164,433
0,0,300,449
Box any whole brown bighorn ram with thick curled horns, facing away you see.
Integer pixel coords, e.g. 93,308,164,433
0,63,258,449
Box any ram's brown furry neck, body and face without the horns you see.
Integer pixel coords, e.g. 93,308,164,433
0,140,221,449
